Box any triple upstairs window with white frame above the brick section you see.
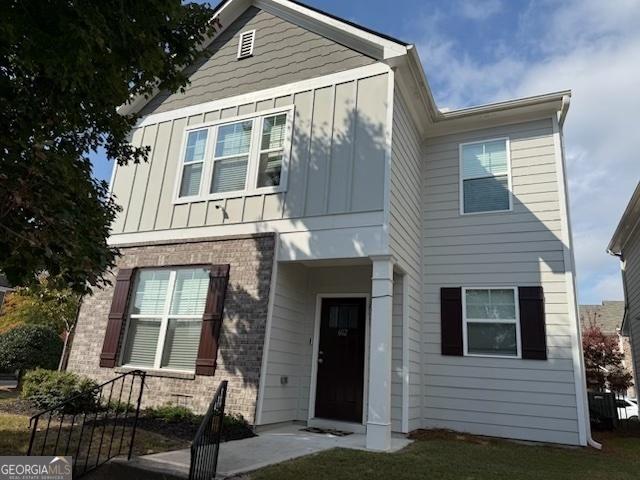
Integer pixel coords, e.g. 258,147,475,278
176,107,293,202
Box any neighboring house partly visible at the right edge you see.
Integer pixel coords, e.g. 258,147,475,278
608,182,640,404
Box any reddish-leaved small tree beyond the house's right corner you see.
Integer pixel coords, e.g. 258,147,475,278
582,323,633,392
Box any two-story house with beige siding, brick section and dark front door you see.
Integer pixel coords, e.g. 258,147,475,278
69,0,590,450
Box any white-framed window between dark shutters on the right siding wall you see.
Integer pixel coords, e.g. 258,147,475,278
462,288,520,357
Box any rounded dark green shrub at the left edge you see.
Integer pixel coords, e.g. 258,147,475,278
0,325,63,370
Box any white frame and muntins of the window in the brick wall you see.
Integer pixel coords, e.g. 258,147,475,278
118,265,211,373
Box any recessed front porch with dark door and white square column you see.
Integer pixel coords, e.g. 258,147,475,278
256,256,407,451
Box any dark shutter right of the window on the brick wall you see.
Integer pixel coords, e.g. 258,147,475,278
196,265,229,376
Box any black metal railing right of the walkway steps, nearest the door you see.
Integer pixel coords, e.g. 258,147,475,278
189,380,227,480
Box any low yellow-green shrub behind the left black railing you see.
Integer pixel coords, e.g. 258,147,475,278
21,368,97,413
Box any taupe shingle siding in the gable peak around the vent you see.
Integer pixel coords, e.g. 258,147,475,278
141,7,375,115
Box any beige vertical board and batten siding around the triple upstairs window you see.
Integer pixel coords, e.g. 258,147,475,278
111,73,388,235
